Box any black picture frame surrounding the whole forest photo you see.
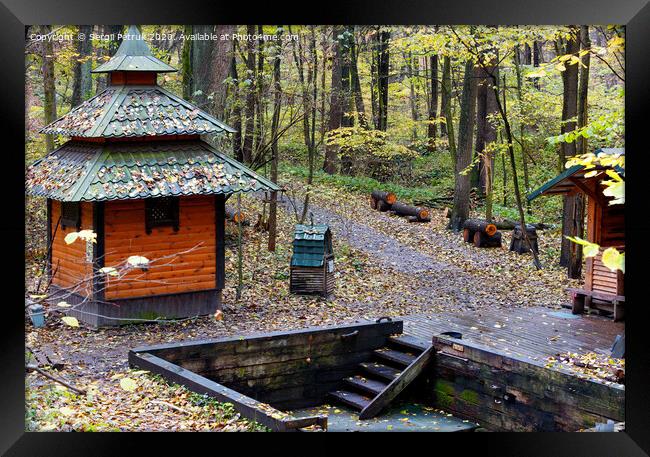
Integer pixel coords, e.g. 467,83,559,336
6,0,650,457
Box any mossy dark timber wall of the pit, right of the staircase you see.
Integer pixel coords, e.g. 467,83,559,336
433,336,625,431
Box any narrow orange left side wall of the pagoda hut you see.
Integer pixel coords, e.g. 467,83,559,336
50,200,93,297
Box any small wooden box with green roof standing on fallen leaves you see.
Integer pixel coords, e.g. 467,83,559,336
289,224,334,297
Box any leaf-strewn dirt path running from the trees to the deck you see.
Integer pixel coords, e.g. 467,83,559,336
281,191,566,312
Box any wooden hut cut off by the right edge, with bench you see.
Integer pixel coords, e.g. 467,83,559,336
528,148,625,320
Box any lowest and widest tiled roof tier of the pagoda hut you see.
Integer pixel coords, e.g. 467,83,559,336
26,140,280,201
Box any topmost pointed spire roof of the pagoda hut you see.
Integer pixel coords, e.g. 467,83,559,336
92,25,178,73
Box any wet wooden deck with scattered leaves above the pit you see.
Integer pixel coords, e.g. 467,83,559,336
400,307,625,361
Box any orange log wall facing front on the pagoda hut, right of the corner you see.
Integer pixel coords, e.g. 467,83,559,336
104,195,217,300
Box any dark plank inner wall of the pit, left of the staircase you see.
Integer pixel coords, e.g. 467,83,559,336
136,321,402,409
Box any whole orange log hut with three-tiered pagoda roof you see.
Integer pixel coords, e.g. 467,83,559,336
26,26,279,326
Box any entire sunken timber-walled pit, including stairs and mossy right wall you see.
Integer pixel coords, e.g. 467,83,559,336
129,318,625,431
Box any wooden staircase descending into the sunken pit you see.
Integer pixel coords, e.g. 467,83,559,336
329,335,435,419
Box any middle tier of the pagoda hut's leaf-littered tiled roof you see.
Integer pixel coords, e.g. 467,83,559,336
41,85,235,138
